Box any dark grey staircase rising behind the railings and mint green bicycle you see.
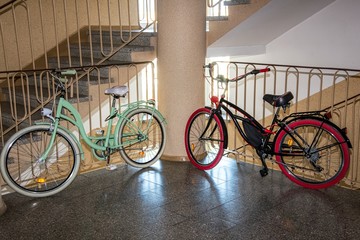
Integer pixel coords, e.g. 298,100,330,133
0,28,156,145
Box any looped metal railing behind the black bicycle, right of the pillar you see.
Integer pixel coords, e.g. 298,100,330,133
205,62,360,188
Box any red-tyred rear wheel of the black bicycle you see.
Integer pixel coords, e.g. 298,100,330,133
275,119,350,189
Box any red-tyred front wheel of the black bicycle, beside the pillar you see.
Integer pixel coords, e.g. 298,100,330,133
185,108,225,170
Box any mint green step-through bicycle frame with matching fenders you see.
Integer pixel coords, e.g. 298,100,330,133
37,96,165,160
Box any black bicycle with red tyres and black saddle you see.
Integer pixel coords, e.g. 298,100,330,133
185,64,352,189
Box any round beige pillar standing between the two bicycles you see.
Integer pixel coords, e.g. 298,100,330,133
157,0,206,161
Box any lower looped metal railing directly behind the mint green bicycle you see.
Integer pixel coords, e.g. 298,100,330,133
0,61,157,171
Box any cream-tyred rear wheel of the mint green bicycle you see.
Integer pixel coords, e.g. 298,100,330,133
119,108,166,168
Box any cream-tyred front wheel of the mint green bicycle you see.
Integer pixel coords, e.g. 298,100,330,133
0,125,80,197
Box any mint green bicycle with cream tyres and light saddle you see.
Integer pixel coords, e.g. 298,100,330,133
0,70,166,197
